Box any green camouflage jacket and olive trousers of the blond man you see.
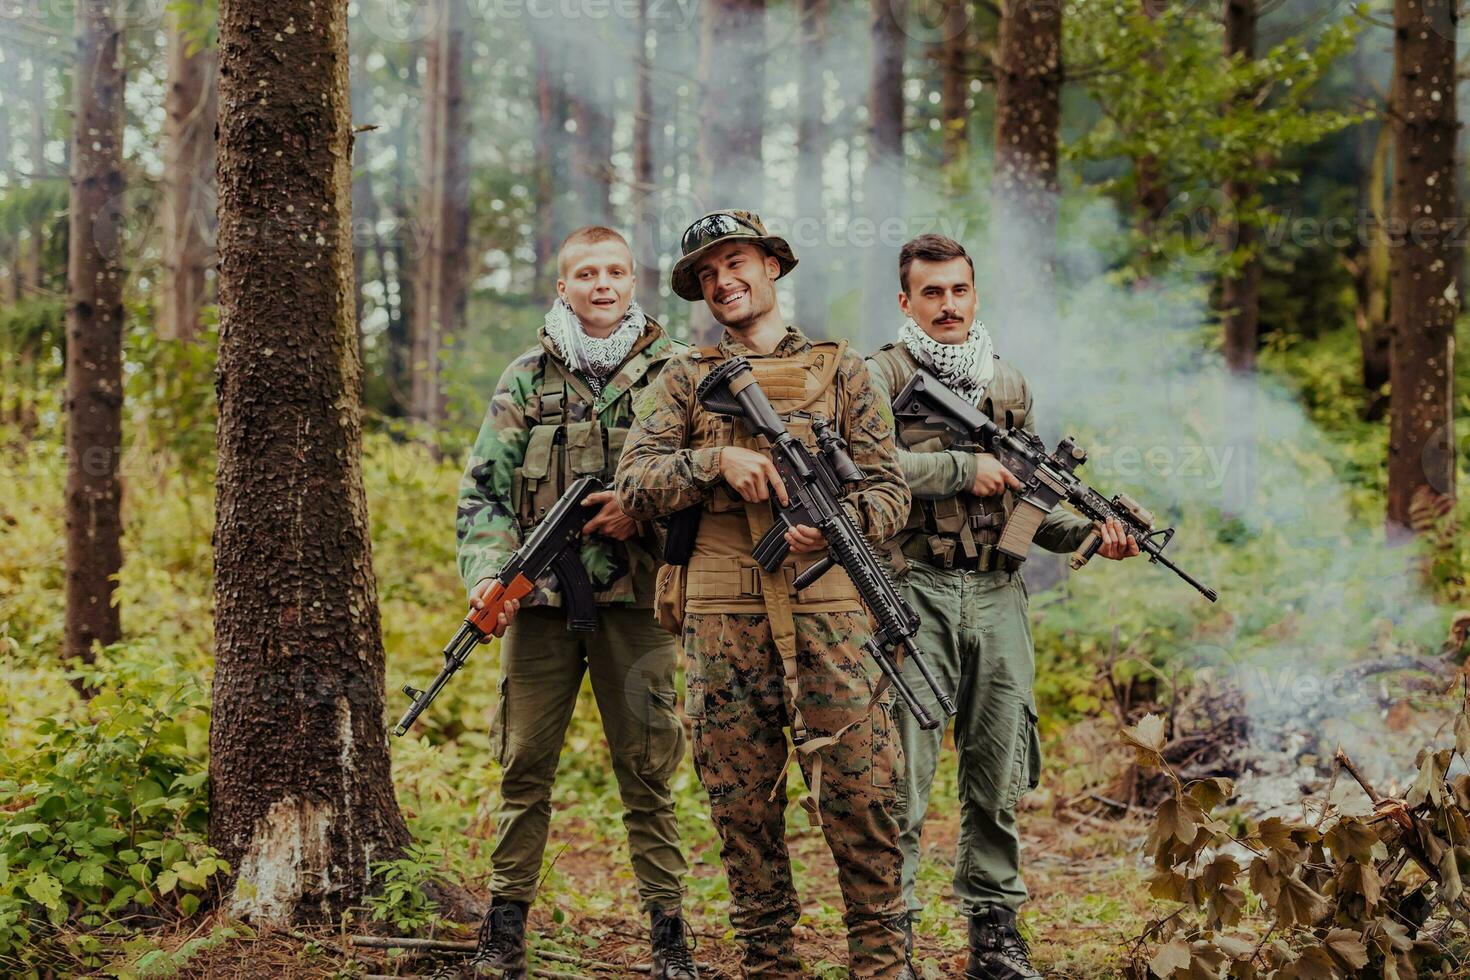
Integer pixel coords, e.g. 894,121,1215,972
457,320,686,911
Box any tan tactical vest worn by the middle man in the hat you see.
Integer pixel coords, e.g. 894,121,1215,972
685,342,863,613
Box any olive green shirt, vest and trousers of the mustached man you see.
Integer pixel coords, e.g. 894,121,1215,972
867,344,1092,915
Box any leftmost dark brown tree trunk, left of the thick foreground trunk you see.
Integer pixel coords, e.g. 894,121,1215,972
62,1,125,661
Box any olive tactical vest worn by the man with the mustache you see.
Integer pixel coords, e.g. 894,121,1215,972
870,344,1026,573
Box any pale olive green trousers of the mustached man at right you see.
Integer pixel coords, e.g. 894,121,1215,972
897,560,1041,915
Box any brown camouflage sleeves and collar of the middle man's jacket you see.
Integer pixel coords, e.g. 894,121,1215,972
616,326,908,542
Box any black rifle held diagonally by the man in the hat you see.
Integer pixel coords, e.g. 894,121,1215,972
695,357,956,729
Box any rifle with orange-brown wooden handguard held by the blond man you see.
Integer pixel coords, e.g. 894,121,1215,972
392,476,606,735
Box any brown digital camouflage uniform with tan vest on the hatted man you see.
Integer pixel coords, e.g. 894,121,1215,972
617,328,908,980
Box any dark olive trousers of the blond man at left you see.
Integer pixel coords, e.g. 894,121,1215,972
490,605,688,911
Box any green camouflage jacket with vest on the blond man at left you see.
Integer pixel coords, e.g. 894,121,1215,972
456,319,682,607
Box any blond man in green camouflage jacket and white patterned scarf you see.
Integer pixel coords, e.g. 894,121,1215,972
457,226,698,980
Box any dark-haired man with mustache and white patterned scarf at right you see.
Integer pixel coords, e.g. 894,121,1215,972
867,235,1138,980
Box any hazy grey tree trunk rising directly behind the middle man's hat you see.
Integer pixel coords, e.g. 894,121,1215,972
696,0,766,344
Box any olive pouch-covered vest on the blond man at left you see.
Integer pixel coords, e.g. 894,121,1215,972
510,325,672,532
